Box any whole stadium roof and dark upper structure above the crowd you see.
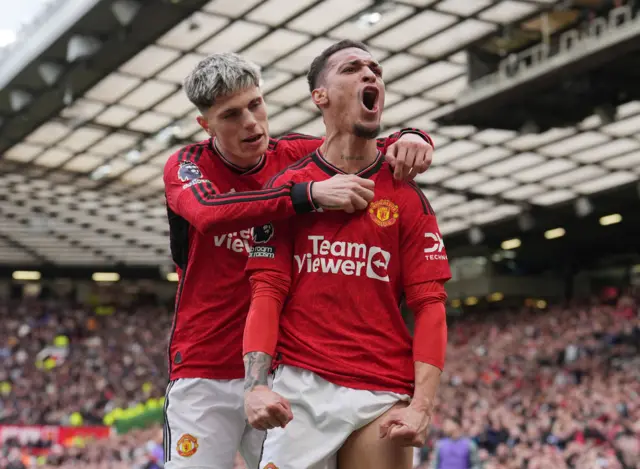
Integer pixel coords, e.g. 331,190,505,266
0,0,640,468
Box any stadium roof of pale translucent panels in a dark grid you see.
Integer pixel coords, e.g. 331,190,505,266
0,0,640,265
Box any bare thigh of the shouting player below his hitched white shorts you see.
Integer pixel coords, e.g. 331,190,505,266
338,402,413,469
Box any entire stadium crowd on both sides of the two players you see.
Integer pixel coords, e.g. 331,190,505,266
0,288,640,469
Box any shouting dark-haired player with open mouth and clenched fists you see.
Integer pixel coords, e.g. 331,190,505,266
244,41,451,469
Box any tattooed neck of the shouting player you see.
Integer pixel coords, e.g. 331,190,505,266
320,131,378,174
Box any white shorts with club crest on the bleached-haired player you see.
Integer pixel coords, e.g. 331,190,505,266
164,378,265,469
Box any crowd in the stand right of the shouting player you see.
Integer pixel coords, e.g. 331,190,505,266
423,290,640,469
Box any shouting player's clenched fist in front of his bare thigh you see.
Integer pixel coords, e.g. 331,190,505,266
380,405,431,448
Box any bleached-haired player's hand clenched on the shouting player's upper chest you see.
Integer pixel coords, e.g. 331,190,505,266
311,174,375,213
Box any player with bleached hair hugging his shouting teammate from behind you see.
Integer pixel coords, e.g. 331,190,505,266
164,54,432,469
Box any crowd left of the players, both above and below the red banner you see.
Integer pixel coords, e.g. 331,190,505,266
0,300,171,469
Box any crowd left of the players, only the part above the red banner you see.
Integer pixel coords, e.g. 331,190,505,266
0,301,171,425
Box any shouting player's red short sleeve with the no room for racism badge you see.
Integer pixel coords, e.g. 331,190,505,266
245,220,293,277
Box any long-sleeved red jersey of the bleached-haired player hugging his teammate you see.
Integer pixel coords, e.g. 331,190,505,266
164,129,431,380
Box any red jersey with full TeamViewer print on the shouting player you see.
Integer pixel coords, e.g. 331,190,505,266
247,150,451,395
